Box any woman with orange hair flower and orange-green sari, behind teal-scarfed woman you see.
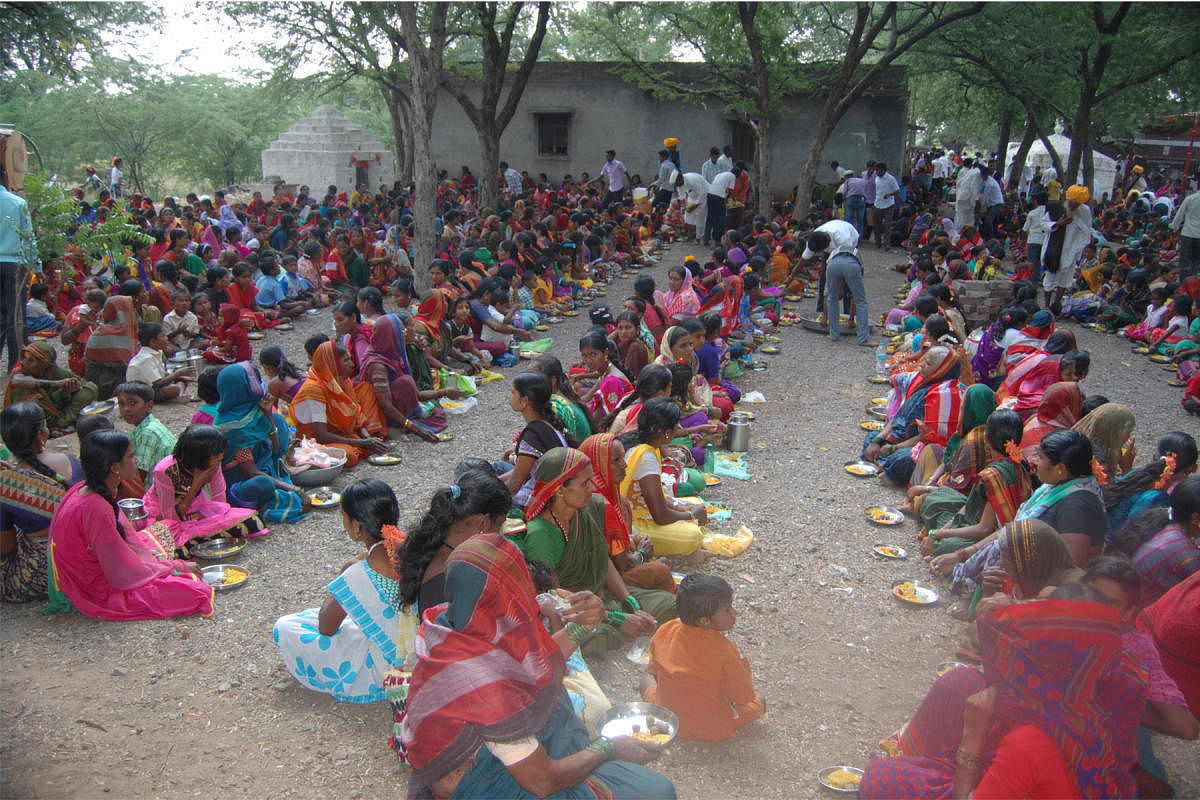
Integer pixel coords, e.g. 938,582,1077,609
920,407,1032,557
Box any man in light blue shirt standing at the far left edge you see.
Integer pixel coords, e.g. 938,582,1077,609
0,172,41,372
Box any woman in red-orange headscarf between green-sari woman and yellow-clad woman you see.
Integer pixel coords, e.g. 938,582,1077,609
580,433,676,593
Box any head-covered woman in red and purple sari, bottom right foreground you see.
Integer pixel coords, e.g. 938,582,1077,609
859,599,1147,800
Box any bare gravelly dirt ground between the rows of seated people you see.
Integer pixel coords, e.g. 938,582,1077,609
0,236,1200,799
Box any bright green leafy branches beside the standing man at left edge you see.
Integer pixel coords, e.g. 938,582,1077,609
24,173,154,264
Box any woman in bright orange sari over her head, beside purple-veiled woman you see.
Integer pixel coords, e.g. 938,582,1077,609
288,342,388,467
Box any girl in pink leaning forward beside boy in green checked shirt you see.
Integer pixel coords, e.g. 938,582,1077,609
142,425,268,552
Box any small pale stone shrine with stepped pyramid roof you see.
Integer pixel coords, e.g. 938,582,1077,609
263,106,396,197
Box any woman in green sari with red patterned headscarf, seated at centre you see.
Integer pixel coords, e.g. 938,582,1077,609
520,447,676,656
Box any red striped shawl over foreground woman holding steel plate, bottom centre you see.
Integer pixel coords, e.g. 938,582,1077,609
401,534,564,798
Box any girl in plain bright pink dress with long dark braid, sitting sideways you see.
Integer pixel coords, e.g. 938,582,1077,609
49,431,212,620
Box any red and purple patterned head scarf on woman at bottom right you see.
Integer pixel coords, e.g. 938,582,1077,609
978,600,1148,798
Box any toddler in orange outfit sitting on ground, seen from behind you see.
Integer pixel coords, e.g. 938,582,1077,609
642,575,766,741
